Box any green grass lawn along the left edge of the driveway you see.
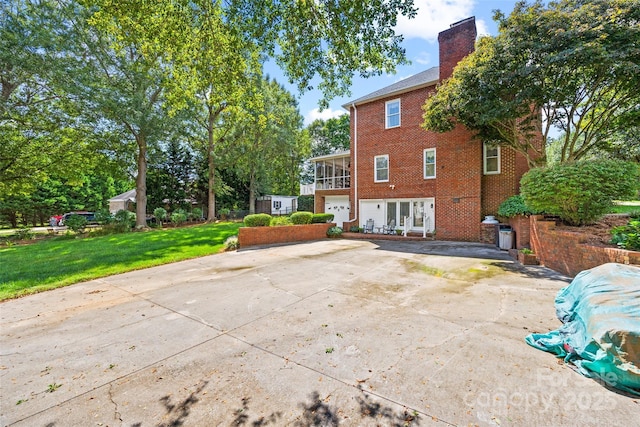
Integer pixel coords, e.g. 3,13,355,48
0,223,240,301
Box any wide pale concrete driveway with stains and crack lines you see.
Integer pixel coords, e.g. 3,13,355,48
0,240,640,426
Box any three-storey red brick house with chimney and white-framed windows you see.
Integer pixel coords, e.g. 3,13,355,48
312,17,528,241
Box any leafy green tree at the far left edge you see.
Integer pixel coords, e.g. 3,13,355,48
0,1,95,197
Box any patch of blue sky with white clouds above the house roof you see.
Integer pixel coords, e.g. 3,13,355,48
265,0,516,126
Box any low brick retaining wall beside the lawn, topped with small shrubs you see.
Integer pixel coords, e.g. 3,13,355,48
238,223,335,248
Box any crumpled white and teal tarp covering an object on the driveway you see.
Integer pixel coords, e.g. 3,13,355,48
525,263,640,395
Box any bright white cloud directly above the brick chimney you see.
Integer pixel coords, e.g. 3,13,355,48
396,0,478,42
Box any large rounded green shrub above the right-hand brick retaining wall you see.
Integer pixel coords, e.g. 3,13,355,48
520,160,640,225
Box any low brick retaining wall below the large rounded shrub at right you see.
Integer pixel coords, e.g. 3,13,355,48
530,216,640,277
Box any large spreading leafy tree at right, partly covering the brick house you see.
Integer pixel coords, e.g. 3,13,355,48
424,0,640,166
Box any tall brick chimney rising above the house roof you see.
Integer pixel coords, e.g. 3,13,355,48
438,16,478,81
